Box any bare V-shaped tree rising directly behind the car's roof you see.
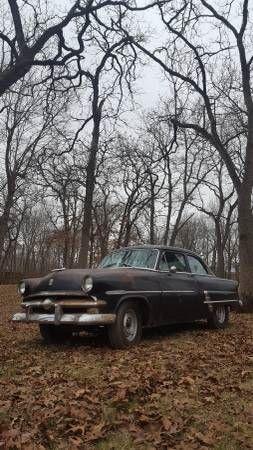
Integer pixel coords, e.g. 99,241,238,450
143,112,214,245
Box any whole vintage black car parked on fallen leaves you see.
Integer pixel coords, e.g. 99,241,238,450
13,246,240,348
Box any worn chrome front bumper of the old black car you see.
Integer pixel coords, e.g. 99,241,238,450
12,308,116,325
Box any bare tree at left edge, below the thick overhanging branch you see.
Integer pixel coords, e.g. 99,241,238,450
0,77,65,268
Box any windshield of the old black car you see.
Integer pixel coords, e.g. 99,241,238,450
99,248,158,269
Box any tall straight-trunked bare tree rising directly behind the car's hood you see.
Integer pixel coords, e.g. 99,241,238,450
78,25,136,267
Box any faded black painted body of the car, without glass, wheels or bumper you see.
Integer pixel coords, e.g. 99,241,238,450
18,246,237,326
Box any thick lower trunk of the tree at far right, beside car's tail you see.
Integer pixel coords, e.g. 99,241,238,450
238,183,253,311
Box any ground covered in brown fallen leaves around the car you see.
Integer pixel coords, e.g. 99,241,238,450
0,286,253,450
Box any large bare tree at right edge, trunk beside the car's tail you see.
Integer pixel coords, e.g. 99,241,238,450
131,0,253,303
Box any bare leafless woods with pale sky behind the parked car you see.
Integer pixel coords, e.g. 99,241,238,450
0,0,253,310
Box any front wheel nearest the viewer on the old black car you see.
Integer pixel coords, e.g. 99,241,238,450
108,302,142,348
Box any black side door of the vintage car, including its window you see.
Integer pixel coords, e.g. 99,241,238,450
158,250,200,323
